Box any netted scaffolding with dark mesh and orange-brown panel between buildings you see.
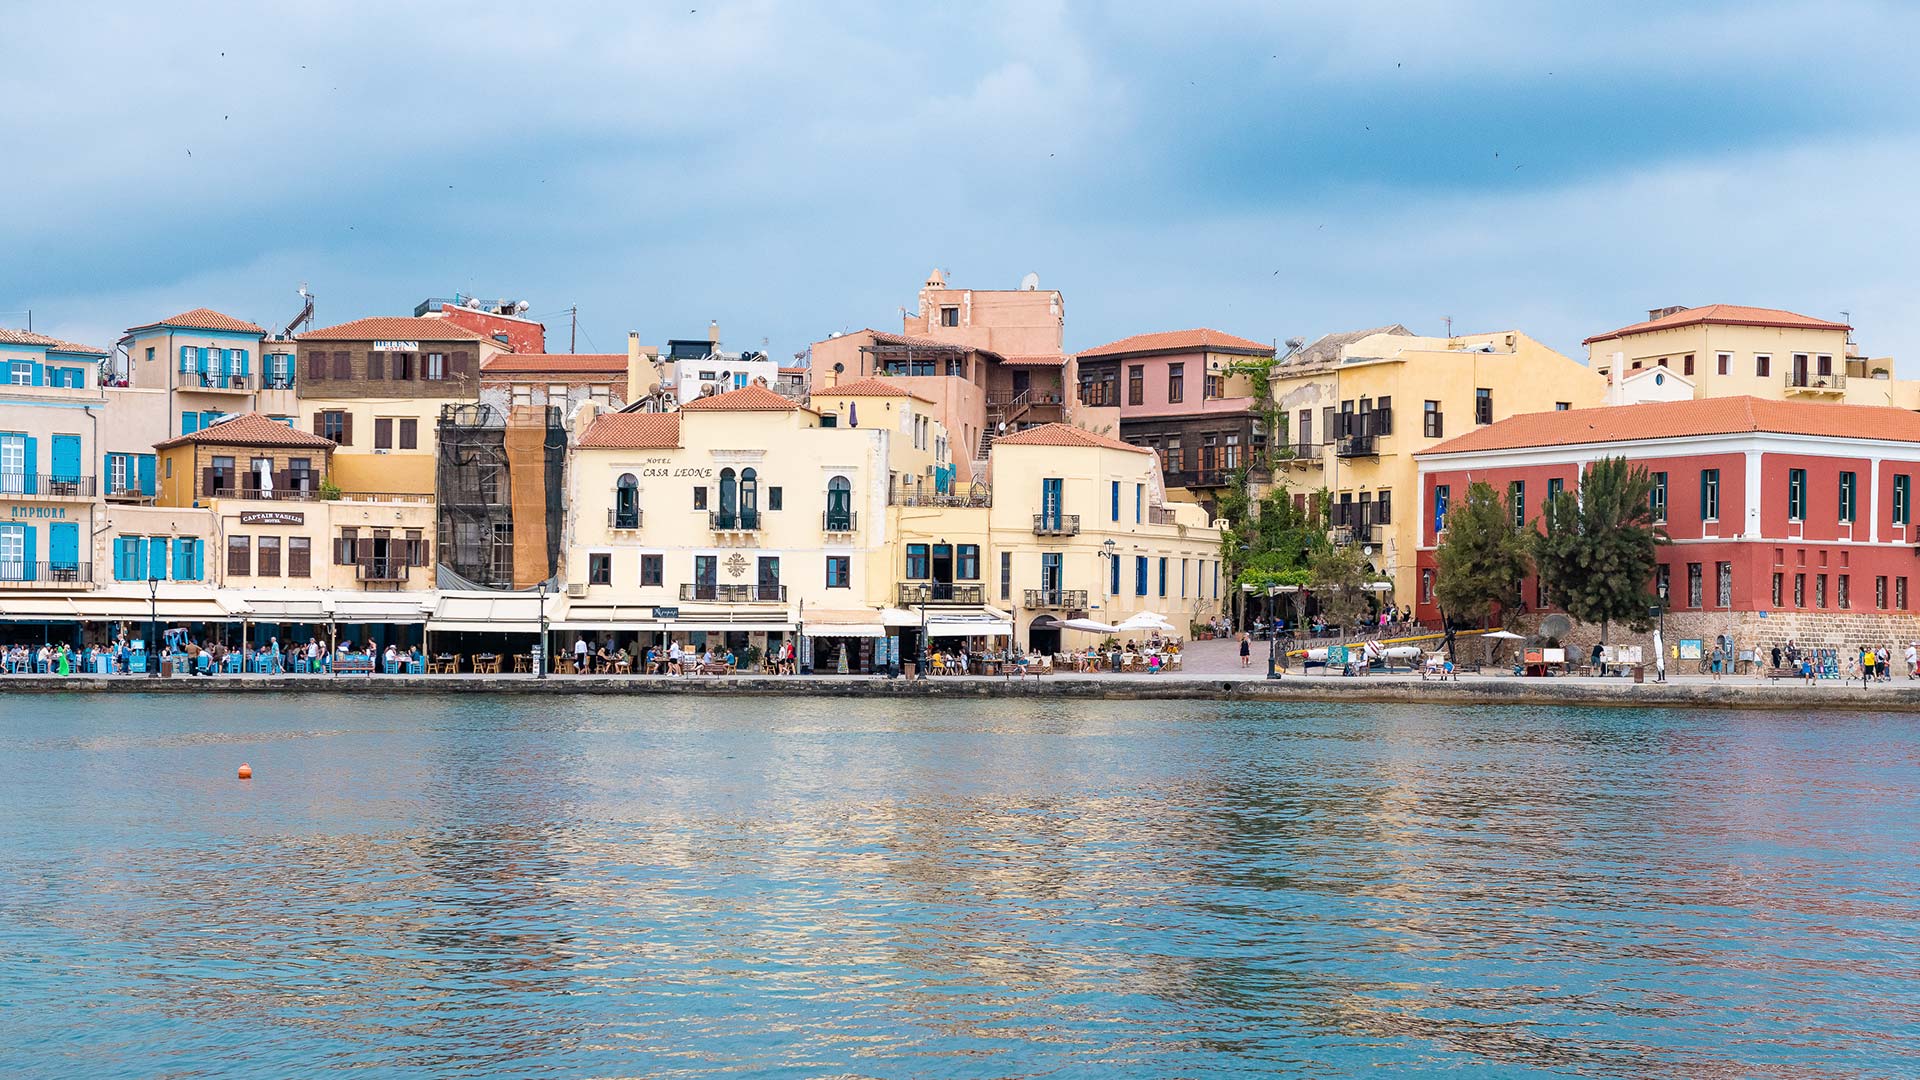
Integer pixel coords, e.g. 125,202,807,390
434,404,566,588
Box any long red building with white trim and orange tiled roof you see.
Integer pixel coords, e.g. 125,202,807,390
1415,398,1920,646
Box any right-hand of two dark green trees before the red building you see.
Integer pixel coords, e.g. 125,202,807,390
1534,457,1667,642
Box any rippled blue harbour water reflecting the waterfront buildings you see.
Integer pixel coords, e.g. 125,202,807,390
0,694,1920,1078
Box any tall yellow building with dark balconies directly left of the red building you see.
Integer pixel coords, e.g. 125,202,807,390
1271,327,1607,603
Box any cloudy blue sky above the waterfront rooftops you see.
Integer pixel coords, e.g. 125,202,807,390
0,0,1920,365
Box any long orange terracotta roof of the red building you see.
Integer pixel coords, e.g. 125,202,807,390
1419,398,1920,457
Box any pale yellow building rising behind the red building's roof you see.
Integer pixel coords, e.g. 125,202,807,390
1584,304,1920,409
